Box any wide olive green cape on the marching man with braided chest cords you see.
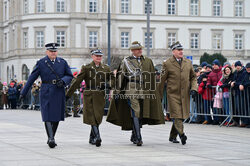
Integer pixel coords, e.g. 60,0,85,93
107,57,165,130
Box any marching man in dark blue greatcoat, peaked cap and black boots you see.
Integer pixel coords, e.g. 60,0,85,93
20,43,73,148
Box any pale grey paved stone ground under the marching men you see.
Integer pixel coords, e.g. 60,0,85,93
0,110,250,166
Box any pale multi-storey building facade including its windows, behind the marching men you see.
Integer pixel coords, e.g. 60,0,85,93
0,0,250,82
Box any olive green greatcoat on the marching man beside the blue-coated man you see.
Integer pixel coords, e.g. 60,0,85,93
66,61,113,126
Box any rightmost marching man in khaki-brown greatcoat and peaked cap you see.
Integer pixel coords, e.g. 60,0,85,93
159,42,197,145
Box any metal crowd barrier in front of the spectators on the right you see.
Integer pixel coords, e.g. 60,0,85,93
189,87,250,126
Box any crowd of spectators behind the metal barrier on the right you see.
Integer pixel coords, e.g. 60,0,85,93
195,59,250,127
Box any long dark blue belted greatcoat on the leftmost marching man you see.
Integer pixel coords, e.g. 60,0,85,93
21,56,73,122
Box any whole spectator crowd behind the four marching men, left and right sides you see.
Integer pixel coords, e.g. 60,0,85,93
0,59,250,127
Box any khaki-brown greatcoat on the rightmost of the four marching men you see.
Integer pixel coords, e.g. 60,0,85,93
159,56,197,119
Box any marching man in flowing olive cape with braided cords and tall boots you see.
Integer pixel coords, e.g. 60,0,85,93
107,41,164,146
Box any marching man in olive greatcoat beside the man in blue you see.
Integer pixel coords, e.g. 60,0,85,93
66,49,113,147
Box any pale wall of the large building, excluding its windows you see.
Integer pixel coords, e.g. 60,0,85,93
0,0,250,80
